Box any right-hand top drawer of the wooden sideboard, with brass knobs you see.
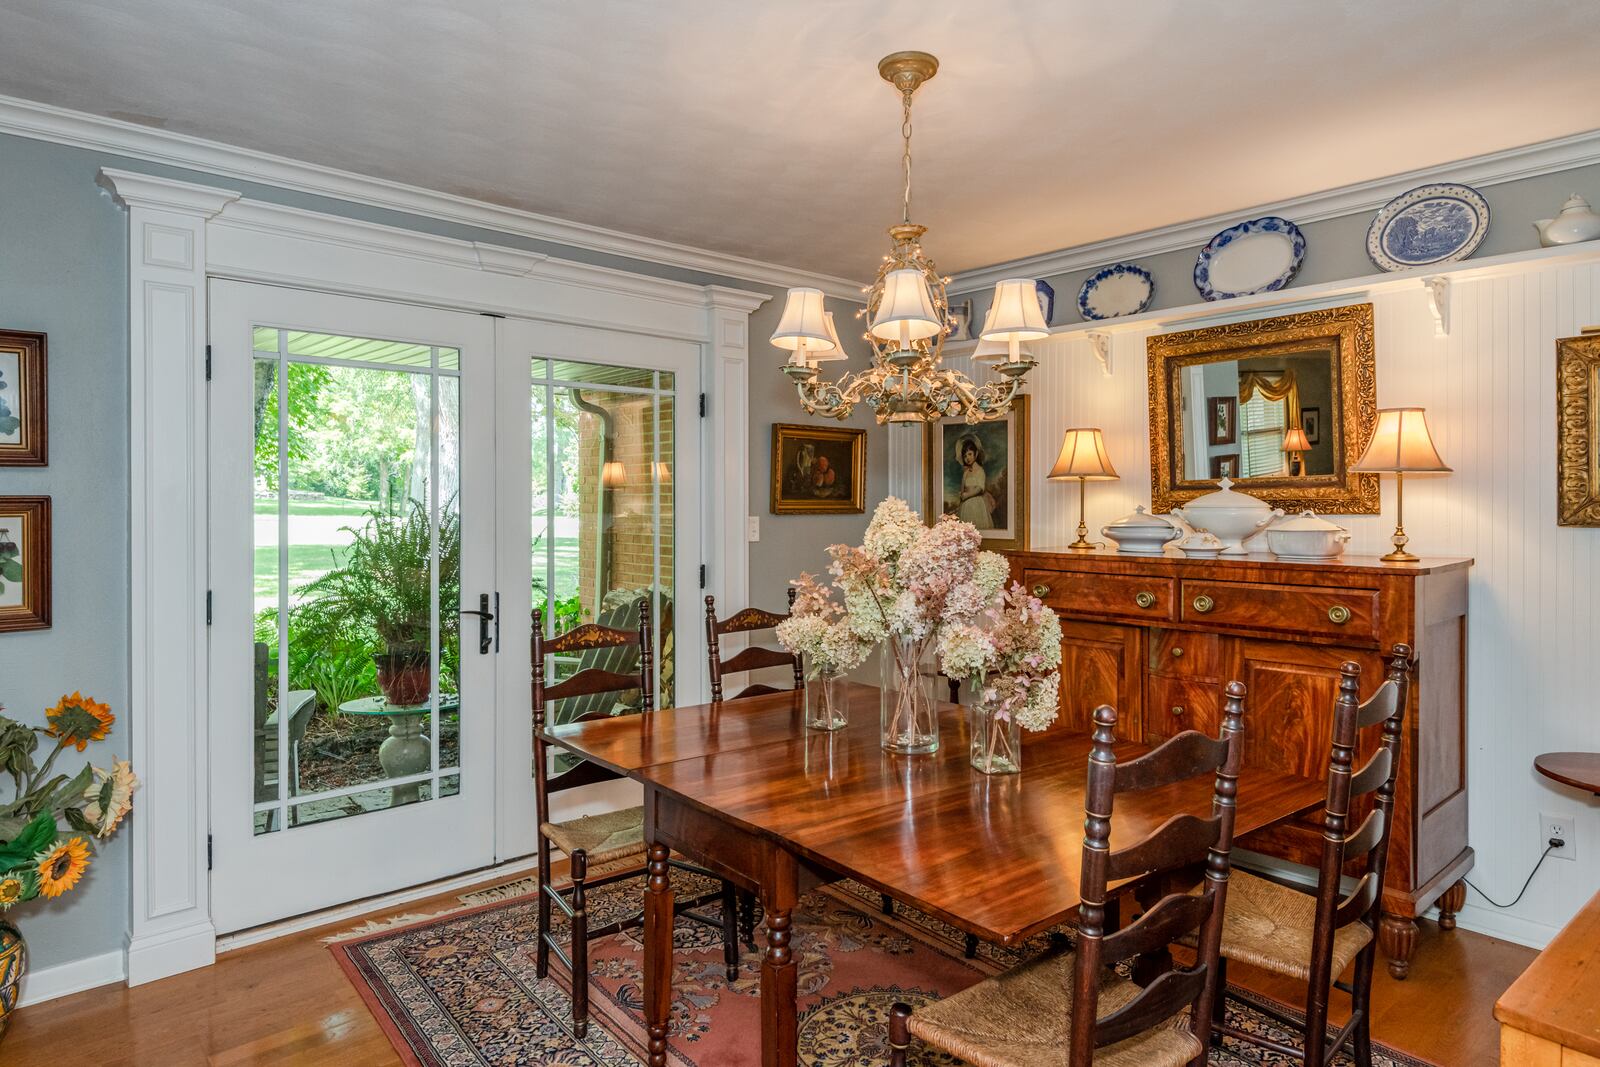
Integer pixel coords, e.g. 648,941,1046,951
1178,581,1378,641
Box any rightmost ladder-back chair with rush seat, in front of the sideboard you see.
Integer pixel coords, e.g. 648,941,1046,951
1213,645,1411,1067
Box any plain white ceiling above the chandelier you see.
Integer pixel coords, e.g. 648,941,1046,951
0,0,1600,277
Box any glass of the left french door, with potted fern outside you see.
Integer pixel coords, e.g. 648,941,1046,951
254,326,460,833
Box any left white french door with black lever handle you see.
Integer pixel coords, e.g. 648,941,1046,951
210,282,496,933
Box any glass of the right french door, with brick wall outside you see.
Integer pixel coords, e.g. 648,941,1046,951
530,358,675,721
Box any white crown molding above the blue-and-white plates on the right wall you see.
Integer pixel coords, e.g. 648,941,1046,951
949,130,1600,294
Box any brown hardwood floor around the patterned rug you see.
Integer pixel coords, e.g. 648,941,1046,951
9,893,1534,1067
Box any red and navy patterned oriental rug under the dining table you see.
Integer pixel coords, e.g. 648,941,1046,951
331,875,1422,1067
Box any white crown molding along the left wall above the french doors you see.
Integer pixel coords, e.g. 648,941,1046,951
0,96,861,302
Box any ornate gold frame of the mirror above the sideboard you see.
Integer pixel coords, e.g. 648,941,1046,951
1146,304,1378,515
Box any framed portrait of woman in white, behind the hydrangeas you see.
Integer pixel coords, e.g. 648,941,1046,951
922,397,1029,552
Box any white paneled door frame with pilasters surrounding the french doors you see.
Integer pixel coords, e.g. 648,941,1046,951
98,168,770,985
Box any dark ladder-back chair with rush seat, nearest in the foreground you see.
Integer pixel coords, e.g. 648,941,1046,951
890,681,1245,1067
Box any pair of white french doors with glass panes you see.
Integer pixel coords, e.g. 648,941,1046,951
210,280,706,933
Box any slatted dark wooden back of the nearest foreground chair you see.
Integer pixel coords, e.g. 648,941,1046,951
1069,681,1245,1064
